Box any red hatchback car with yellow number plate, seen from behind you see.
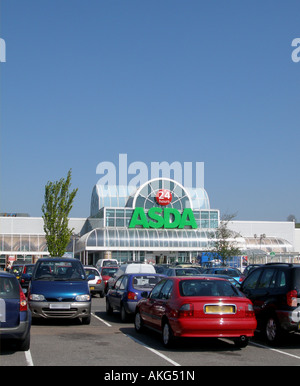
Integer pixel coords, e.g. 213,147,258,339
134,276,257,347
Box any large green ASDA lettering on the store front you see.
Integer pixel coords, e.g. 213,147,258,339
129,207,197,229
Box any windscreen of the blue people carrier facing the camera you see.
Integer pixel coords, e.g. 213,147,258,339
33,260,86,281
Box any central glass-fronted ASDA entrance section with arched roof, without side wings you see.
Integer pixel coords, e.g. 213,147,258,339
75,178,220,264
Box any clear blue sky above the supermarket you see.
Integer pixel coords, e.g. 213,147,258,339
0,0,300,221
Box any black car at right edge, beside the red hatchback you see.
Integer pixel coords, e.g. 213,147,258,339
240,263,300,344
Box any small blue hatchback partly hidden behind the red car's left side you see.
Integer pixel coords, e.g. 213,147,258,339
106,273,165,322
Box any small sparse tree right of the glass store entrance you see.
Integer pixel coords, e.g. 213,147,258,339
212,214,242,265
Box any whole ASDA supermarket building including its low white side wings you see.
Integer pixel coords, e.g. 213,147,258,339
0,178,300,268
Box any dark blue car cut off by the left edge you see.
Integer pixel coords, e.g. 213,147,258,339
0,271,31,351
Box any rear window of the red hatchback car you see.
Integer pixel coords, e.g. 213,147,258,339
179,280,243,296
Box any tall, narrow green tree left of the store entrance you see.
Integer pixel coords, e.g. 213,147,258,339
42,169,78,256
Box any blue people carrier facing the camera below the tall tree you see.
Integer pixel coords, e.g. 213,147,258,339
28,257,94,324
